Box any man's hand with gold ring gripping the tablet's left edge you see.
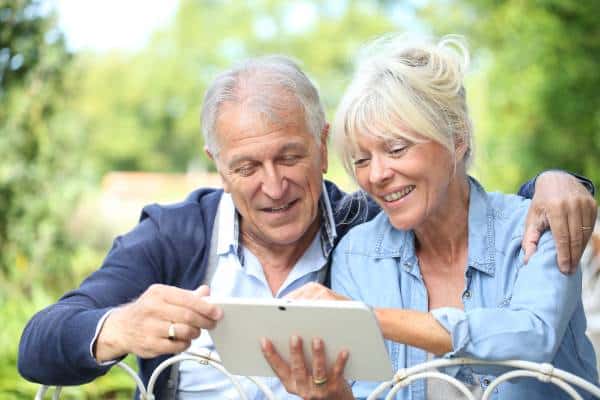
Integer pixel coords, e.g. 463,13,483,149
94,285,223,362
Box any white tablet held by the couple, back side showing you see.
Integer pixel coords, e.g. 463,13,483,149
207,297,393,381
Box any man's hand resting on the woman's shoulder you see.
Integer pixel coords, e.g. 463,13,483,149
522,171,597,273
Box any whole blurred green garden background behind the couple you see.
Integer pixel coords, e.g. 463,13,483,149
0,0,600,399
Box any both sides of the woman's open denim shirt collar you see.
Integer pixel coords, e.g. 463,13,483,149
374,177,496,275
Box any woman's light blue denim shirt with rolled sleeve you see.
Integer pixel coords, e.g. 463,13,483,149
332,178,598,400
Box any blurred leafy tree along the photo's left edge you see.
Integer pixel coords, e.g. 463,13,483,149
0,0,81,300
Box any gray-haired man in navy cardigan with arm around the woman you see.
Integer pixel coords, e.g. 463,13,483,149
19,56,595,399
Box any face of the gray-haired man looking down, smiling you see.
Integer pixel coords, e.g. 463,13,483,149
209,101,327,248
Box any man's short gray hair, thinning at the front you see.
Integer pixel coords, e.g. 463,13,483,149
201,55,325,156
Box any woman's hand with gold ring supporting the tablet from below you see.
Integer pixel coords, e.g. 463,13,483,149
261,336,354,400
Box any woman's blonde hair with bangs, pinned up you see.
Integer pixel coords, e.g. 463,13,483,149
333,34,472,180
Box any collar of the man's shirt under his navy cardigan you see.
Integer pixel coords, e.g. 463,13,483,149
217,183,337,265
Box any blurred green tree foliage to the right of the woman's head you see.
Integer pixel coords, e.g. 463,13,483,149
423,0,600,194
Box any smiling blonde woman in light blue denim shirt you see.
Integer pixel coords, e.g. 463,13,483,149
263,36,597,400
